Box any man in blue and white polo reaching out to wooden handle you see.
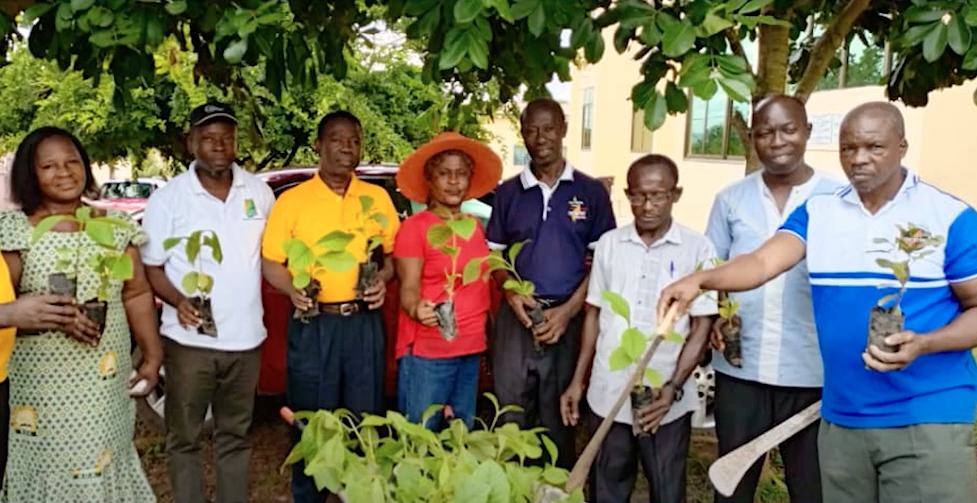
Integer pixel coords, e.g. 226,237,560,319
659,102,977,503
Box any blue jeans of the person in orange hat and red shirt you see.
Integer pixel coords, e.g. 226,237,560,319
397,354,481,431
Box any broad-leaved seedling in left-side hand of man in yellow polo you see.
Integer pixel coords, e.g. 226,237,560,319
283,231,358,323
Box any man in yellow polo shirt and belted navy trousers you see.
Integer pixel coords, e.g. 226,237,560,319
261,111,399,503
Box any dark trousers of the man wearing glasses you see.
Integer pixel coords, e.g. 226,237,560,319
587,412,692,503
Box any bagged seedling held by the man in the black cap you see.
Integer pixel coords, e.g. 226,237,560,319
163,230,224,337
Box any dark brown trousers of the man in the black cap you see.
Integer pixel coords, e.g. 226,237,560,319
163,337,261,503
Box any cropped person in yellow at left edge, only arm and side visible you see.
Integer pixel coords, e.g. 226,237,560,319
0,254,78,478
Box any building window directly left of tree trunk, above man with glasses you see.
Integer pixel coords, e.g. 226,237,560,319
686,88,750,159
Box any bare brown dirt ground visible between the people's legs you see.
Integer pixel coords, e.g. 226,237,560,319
136,397,788,503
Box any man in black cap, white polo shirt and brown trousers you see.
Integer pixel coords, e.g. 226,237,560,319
142,103,275,503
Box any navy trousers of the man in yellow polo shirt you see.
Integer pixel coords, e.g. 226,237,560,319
287,311,384,503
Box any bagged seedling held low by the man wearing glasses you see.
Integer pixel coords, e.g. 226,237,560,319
601,290,685,436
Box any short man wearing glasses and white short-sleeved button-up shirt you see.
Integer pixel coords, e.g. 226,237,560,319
560,154,717,503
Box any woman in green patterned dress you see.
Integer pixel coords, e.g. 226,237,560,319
0,127,162,503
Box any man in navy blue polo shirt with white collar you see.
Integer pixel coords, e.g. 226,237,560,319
486,99,616,469
